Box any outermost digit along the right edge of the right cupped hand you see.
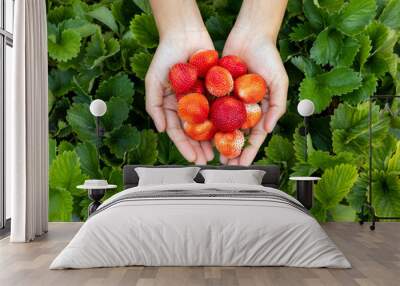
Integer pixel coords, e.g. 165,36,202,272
264,73,289,133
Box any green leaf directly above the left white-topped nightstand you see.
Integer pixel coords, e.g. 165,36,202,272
75,142,103,179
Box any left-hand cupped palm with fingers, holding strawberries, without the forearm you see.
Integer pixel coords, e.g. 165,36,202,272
145,31,214,165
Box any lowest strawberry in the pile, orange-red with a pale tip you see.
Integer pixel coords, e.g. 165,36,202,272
214,130,244,159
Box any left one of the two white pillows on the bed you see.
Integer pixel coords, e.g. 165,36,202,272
135,167,200,186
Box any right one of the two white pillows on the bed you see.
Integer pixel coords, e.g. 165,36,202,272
200,169,265,185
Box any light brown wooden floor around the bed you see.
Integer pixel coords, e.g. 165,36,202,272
0,223,400,286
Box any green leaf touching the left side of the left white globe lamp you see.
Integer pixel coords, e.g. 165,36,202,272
67,103,97,144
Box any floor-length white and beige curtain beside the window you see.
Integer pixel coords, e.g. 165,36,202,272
6,0,48,242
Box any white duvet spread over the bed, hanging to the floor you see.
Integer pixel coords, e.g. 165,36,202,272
50,184,351,269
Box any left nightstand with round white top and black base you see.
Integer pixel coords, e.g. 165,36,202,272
77,180,117,216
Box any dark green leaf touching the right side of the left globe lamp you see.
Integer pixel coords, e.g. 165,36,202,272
101,96,131,131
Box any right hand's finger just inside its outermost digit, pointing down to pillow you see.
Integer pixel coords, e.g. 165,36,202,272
239,116,268,166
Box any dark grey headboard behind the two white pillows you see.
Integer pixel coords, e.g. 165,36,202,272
123,165,280,189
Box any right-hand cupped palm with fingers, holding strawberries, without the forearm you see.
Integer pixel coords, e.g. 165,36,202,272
220,30,289,166
